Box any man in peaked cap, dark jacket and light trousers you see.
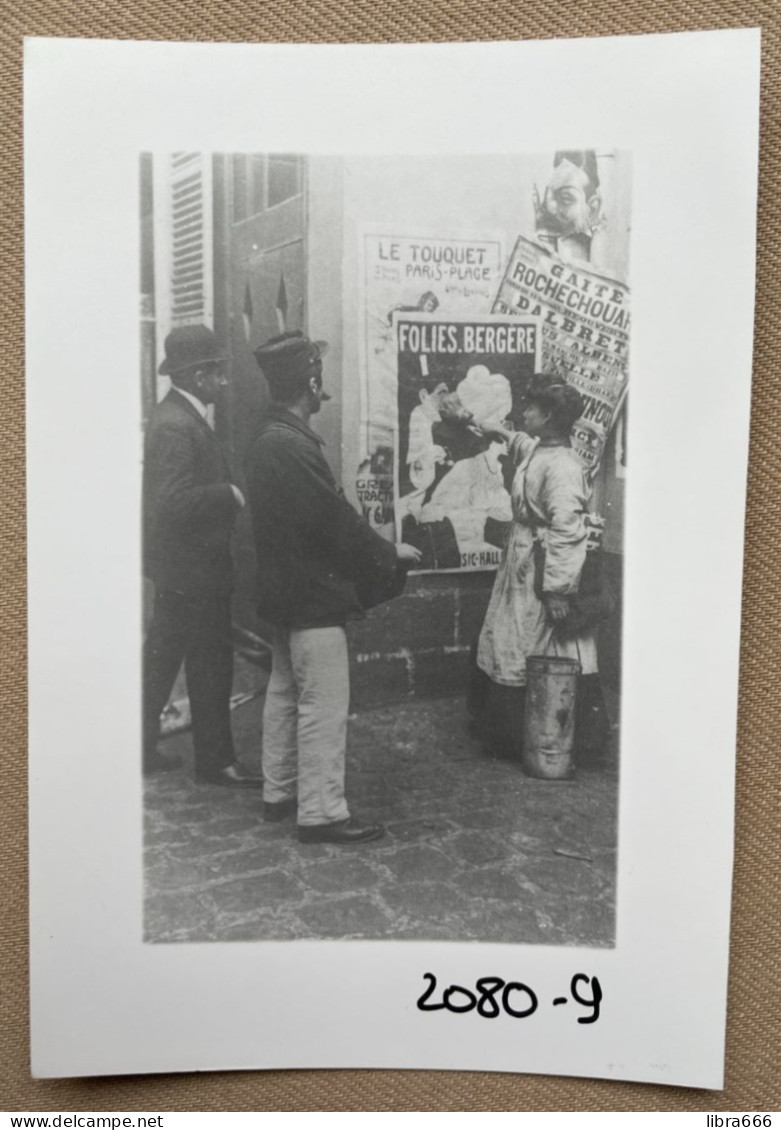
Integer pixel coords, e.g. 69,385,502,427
248,332,419,844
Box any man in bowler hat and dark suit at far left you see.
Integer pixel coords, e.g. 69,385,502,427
144,325,262,788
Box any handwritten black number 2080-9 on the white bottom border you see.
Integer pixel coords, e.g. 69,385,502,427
417,973,602,1024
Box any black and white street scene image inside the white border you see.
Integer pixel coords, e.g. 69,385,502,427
139,148,631,947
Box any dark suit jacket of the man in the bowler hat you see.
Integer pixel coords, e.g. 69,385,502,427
144,389,238,596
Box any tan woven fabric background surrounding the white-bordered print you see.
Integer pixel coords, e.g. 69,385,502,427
0,0,781,1111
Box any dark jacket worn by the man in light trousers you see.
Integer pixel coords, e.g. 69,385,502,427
246,408,398,628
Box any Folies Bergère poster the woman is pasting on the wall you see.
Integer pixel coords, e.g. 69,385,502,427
393,312,540,571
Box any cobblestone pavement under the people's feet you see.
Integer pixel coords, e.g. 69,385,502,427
145,682,618,946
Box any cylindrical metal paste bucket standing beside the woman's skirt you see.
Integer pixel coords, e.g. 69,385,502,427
521,655,581,781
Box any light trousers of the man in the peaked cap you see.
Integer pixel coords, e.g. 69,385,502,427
263,627,349,825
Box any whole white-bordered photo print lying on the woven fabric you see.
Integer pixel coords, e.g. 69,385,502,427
25,31,760,1087
